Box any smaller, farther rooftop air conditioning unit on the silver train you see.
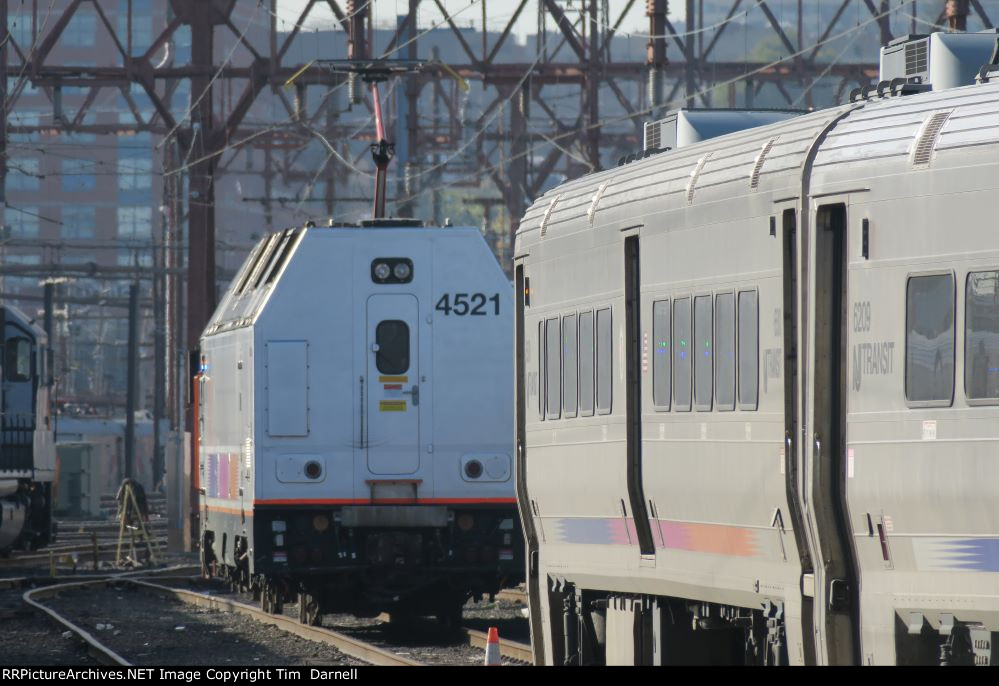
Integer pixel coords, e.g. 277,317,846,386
643,109,804,152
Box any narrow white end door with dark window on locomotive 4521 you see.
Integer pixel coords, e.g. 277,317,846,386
364,294,420,475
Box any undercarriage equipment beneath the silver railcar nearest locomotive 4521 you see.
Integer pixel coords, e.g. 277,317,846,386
548,581,788,665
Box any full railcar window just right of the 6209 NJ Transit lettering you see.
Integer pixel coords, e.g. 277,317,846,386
905,274,954,404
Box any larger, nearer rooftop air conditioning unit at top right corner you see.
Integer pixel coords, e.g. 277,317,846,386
880,29,999,91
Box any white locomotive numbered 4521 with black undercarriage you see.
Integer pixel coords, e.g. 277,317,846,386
195,219,524,624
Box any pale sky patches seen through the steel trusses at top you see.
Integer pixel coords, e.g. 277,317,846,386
278,0,684,41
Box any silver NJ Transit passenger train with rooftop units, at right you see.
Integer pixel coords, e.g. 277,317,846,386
515,32,999,665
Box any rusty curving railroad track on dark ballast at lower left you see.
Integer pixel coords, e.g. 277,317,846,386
23,575,423,666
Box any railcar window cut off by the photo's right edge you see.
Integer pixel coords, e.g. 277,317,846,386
964,271,999,400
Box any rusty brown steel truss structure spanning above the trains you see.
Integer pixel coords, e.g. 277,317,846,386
0,0,992,420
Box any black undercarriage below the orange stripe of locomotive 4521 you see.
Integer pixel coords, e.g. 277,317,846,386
202,511,523,625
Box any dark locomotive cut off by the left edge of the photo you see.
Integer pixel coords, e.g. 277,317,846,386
0,304,56,555
